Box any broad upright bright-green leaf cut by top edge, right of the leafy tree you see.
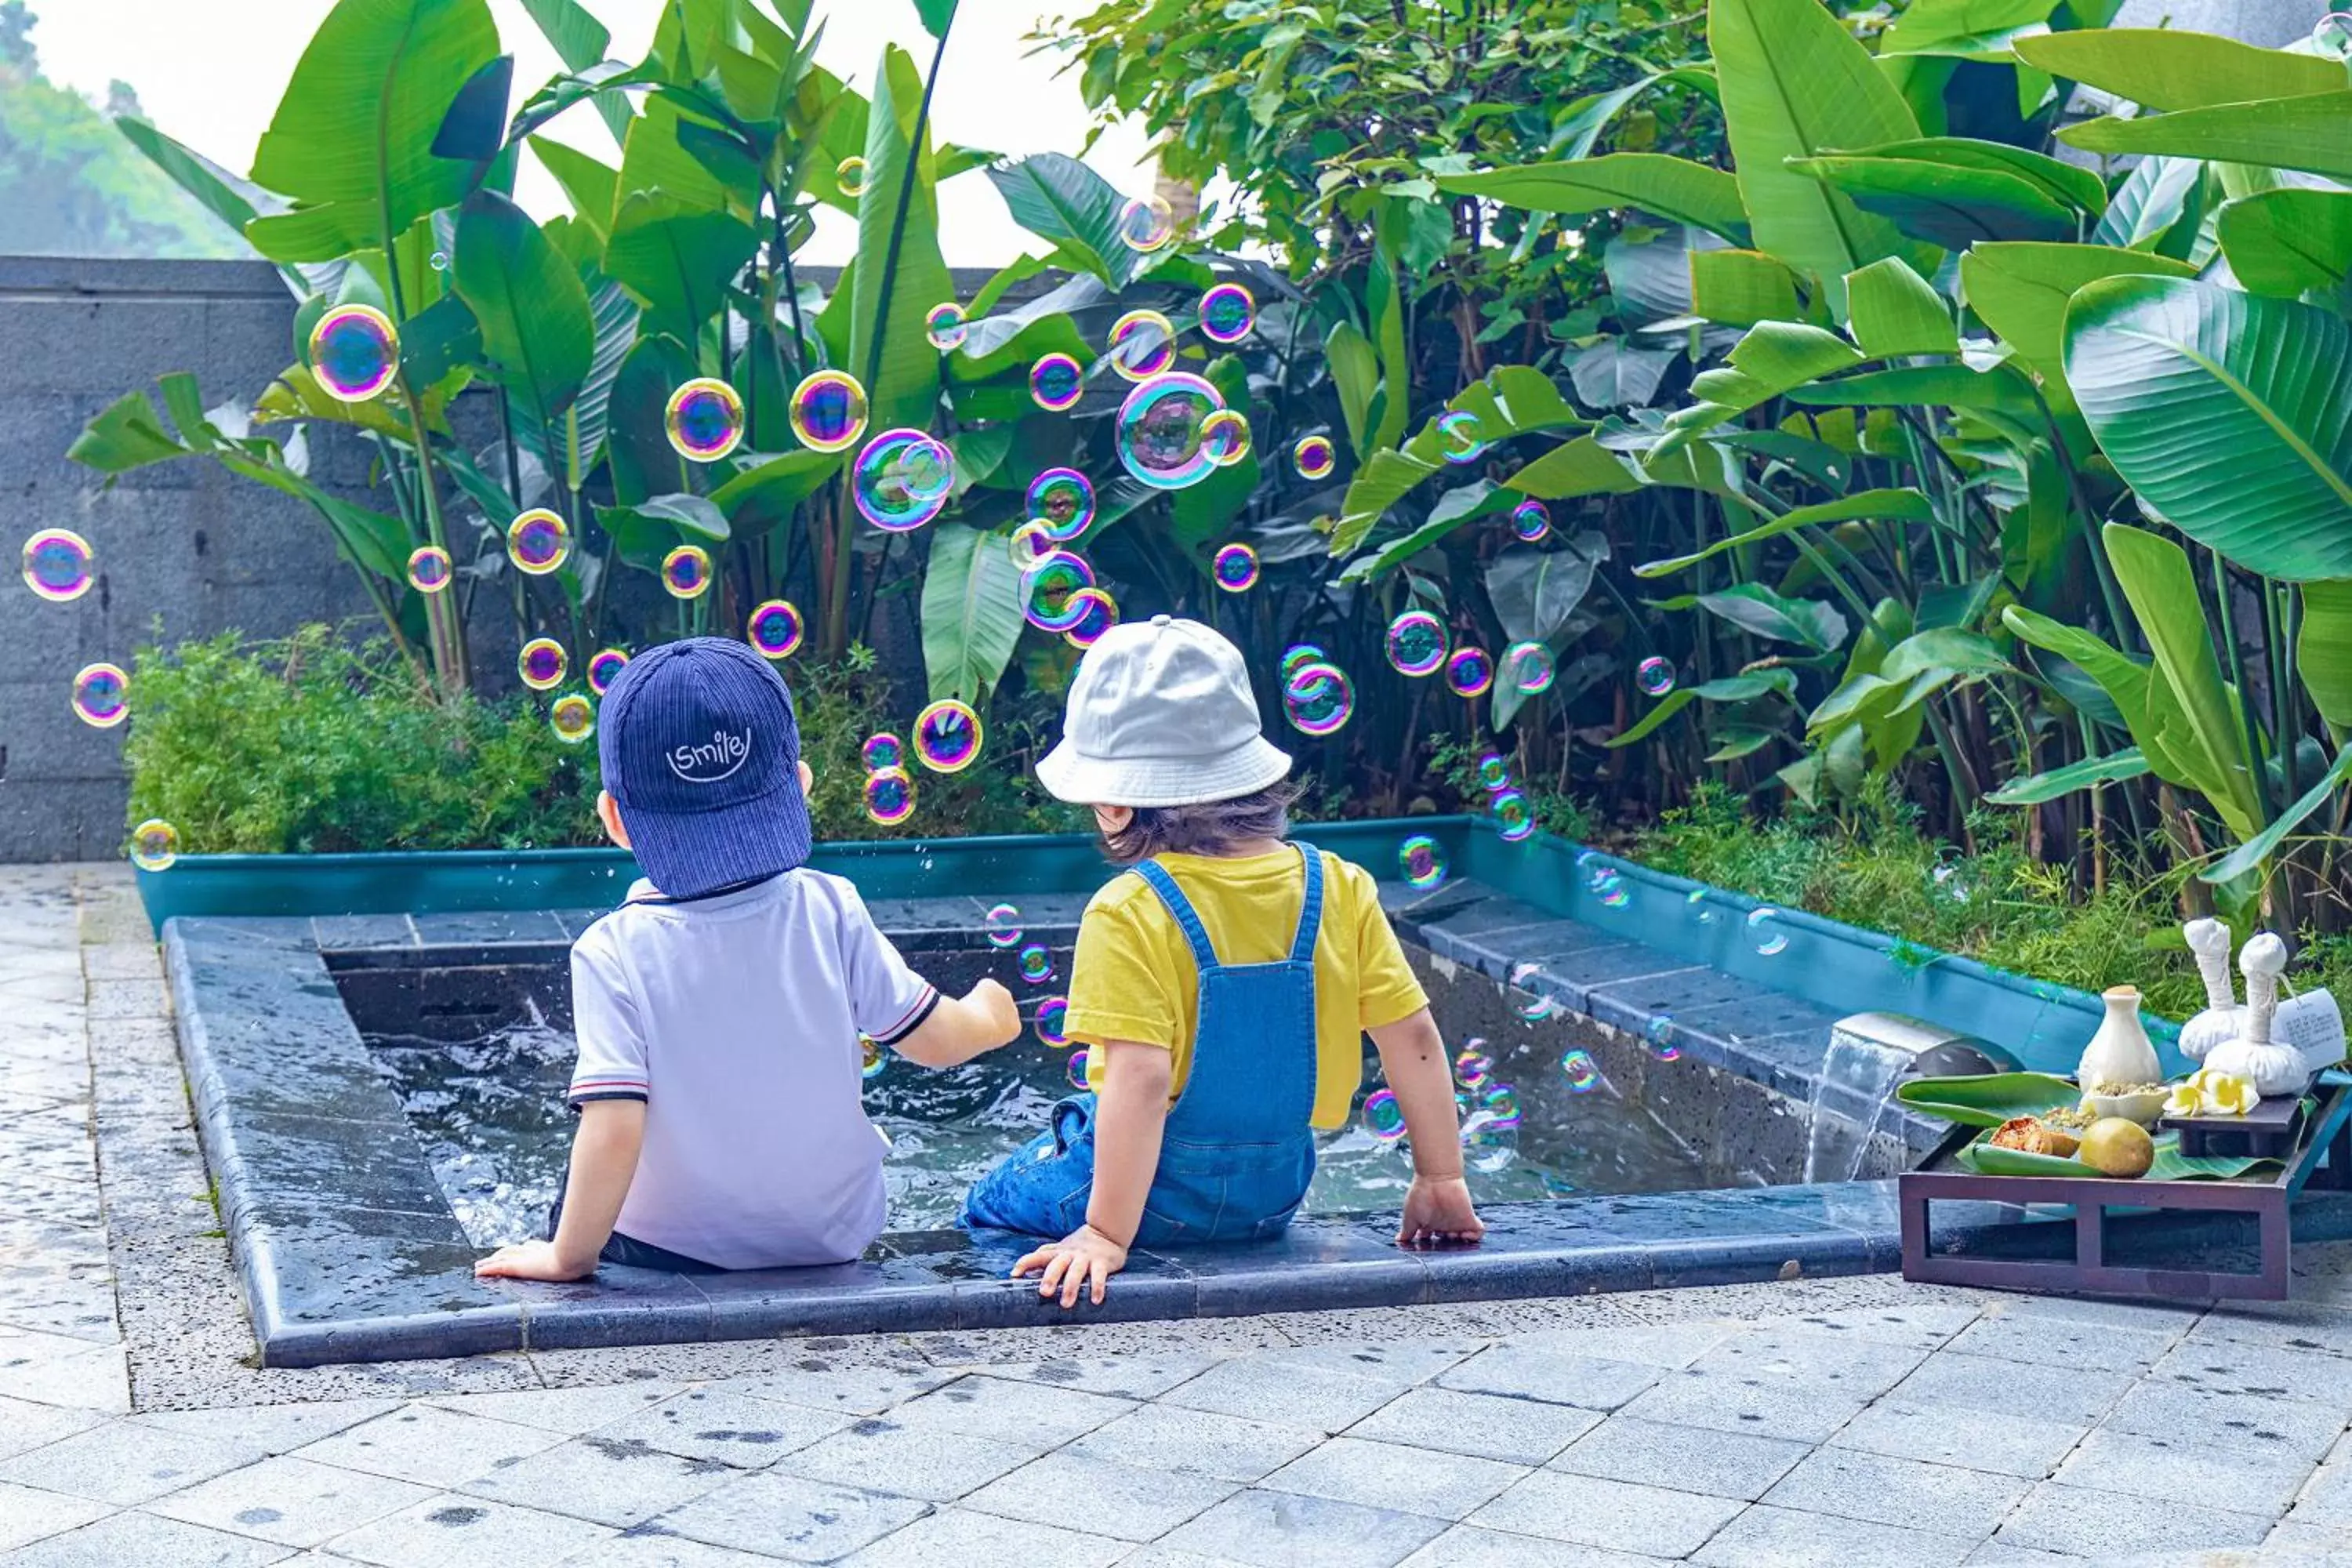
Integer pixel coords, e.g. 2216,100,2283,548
1708,0,1919,308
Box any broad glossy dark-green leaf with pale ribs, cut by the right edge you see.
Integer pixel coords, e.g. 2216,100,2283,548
2065,278,2352,581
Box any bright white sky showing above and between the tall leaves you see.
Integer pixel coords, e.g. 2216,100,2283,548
31,0,1150,266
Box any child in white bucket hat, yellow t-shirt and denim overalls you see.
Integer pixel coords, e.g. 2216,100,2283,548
962,616,1484,1307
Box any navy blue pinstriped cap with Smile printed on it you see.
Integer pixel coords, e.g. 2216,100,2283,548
597,637,811,898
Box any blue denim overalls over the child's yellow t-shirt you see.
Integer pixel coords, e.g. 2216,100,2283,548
962,844,1322,1246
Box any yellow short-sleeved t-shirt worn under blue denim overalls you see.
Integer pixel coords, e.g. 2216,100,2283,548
1065,846,1430,1126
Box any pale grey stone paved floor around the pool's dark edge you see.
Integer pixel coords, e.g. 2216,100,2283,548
0,867,2352,1568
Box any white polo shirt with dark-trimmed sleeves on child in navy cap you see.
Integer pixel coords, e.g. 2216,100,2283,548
572,867,938,1269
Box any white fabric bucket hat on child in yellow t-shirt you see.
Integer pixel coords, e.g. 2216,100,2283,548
1037,616,1291,806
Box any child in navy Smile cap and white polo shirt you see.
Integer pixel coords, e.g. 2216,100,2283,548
475,637,1021,1279
